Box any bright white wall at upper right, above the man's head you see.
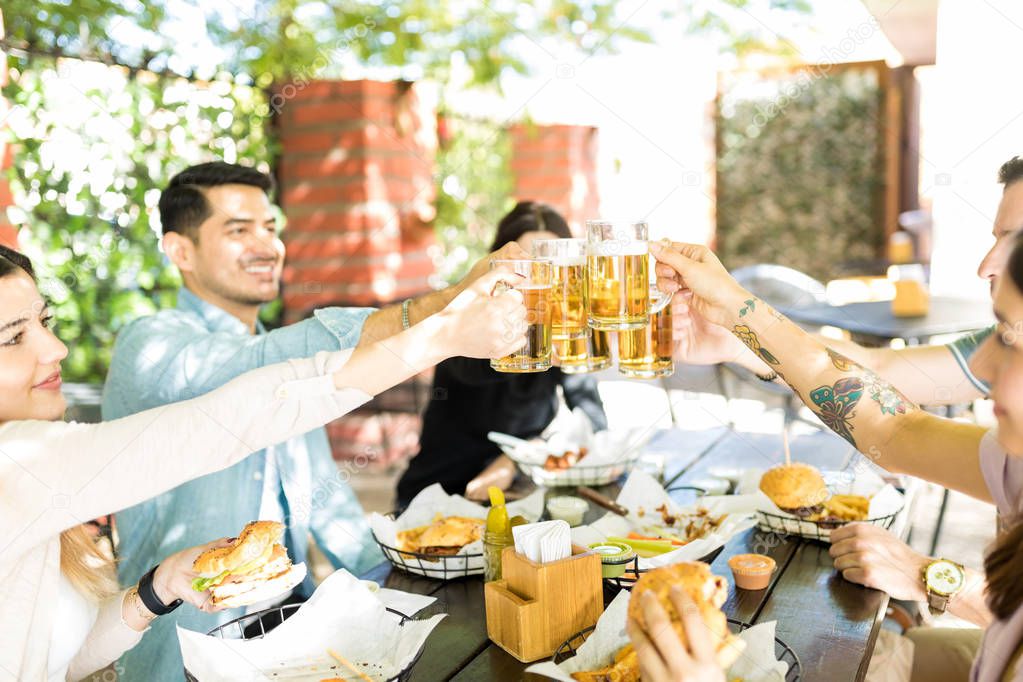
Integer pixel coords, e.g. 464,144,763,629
921,0,1023,300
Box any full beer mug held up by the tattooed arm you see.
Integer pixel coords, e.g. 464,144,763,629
586,220,670,331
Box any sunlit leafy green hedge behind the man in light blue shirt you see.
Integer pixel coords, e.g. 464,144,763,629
5,60,270,381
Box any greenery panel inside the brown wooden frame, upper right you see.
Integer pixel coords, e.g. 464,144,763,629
717,62,885,279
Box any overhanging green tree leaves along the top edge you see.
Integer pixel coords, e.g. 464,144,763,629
4,0,649,87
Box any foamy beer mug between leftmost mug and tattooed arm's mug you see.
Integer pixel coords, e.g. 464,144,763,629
533,239,586,343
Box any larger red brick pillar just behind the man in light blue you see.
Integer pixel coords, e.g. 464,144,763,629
271,81,437,465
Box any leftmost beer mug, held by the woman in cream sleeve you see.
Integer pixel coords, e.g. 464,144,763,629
490,260,552,372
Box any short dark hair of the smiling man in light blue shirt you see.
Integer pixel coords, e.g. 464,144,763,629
160,161,273,241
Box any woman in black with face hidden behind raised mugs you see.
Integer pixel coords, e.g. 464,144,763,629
398,201,608,508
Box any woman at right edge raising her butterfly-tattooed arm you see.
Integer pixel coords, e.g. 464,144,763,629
629,240,1023,682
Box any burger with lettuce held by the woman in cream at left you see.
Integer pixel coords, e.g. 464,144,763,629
192,521,306,608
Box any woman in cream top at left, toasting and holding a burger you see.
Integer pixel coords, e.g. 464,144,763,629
0,242,526,680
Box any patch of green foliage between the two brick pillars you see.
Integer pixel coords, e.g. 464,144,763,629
435,117,515,283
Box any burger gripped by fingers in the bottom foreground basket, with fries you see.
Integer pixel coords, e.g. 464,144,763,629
572,561,746,682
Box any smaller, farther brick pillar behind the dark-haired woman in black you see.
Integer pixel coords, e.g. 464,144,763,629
510,124,599,236
